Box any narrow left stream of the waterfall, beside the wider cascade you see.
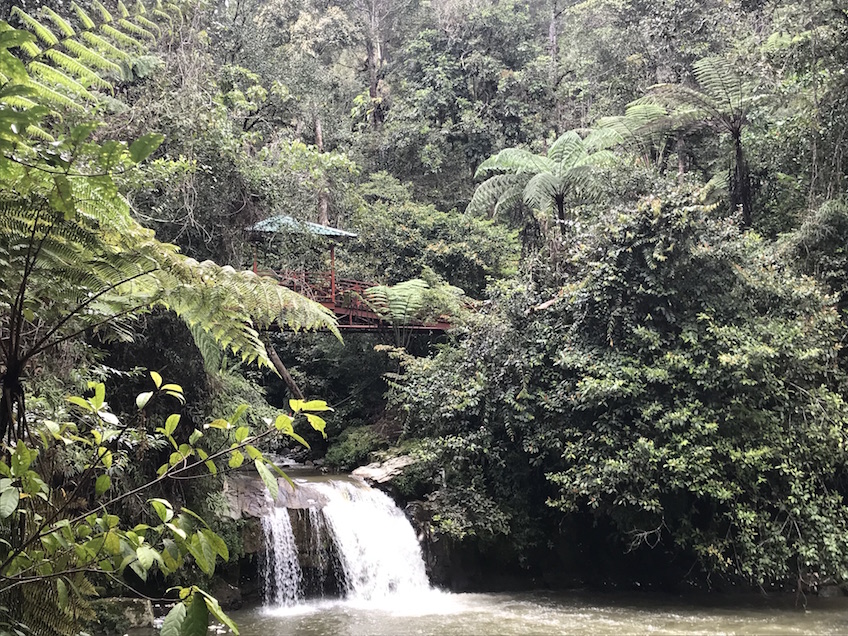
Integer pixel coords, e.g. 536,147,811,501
262,508,303,606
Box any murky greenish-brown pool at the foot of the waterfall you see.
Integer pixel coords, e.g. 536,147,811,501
233,592,848,636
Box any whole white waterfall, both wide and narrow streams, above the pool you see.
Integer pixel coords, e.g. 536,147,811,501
263,480,430,606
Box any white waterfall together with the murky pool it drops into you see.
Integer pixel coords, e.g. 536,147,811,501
243,478,848,636
